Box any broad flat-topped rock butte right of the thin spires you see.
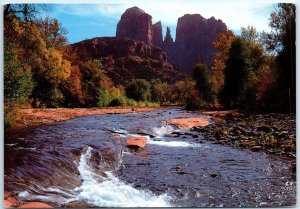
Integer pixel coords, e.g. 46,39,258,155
170,14,227,72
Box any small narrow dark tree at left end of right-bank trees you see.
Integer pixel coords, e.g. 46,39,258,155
193,64,216,103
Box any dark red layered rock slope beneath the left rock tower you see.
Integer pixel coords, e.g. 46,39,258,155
72,38,182,84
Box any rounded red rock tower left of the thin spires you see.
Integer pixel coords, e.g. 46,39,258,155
116,7,152,44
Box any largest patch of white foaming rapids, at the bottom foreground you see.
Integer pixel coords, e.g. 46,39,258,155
69,147,170,207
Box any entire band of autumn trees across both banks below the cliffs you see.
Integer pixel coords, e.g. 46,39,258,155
4,4,296,126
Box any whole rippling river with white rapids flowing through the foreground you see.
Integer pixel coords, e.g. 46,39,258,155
4,109,296,207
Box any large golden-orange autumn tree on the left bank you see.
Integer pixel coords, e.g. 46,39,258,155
4,17,71,107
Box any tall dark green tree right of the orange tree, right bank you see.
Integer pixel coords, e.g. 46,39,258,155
220,33,266,109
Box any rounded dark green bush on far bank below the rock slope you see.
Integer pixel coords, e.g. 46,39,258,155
125,79,151,101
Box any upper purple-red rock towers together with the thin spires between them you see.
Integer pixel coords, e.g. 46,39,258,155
117,7,227,73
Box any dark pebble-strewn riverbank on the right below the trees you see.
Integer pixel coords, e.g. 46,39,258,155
191,112,296,170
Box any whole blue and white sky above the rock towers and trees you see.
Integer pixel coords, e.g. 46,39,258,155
39,0,276,43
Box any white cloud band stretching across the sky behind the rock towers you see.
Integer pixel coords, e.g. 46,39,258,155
42,0,298,31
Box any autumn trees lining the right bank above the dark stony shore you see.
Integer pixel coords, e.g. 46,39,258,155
193,3,296,113
